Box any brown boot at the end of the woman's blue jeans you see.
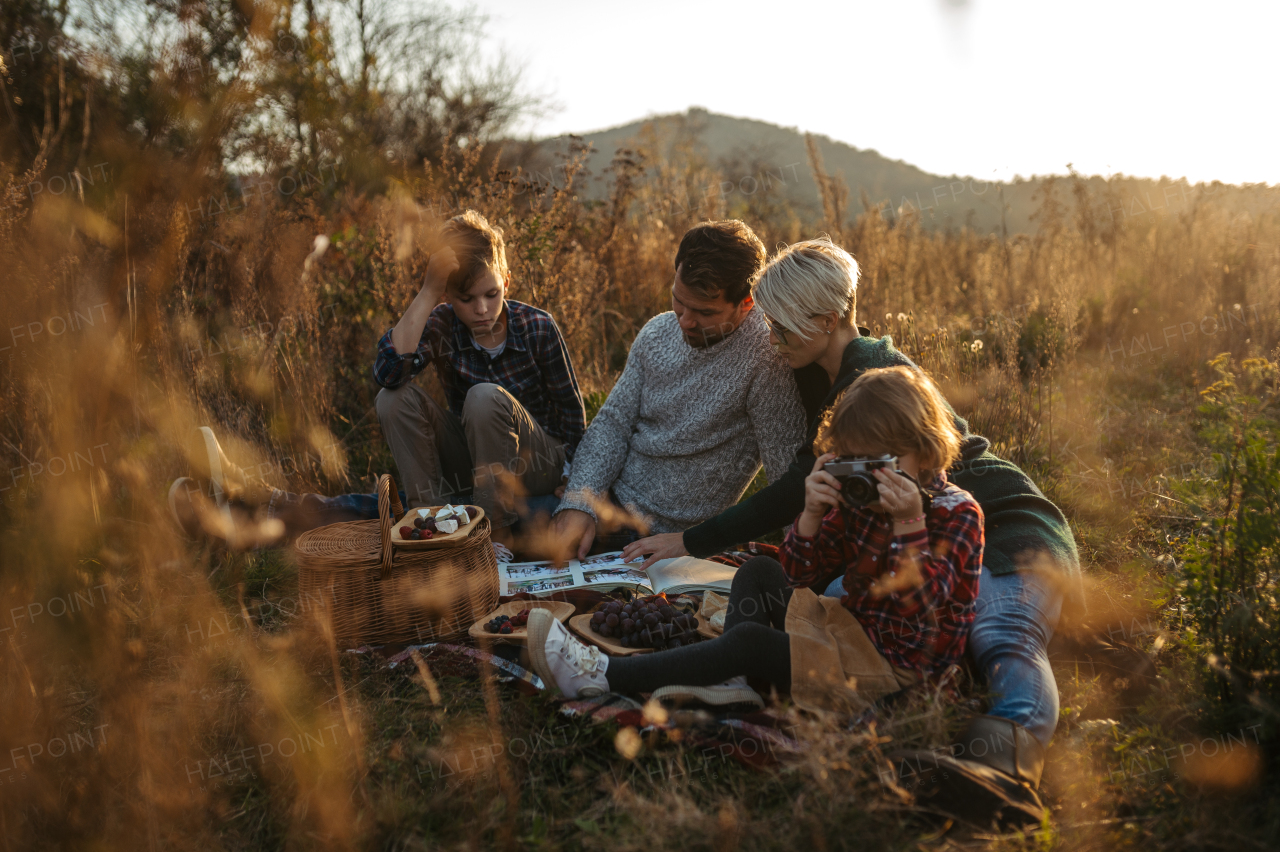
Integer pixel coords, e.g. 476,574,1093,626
888,716,1046,828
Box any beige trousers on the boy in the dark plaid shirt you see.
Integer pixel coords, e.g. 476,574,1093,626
375,381,566,528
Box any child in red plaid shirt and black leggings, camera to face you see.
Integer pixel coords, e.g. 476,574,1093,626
529,367,983,711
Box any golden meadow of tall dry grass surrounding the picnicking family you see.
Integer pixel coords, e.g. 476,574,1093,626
0,4,1280,852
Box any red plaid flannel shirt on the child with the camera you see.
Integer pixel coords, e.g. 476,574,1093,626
780,477,983,675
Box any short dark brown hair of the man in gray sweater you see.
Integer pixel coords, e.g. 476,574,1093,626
676,219,768,304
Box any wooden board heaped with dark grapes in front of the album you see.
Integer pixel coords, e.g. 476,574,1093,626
568,595,705,656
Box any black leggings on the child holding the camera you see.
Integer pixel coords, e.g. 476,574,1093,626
604,556,791,692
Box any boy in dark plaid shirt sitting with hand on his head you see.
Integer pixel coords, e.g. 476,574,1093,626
374,210,586,540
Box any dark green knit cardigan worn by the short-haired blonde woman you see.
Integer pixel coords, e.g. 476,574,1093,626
685,336,1084,609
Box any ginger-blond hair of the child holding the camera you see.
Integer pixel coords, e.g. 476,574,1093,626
817,367,960,473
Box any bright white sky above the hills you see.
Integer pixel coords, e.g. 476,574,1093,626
475,0,1280,184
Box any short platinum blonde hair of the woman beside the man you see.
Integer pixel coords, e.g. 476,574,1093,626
753,237,858,340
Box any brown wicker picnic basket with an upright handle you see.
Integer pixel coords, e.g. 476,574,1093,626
293,473,498,647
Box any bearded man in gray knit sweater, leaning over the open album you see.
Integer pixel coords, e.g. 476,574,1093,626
556,220,804,559
